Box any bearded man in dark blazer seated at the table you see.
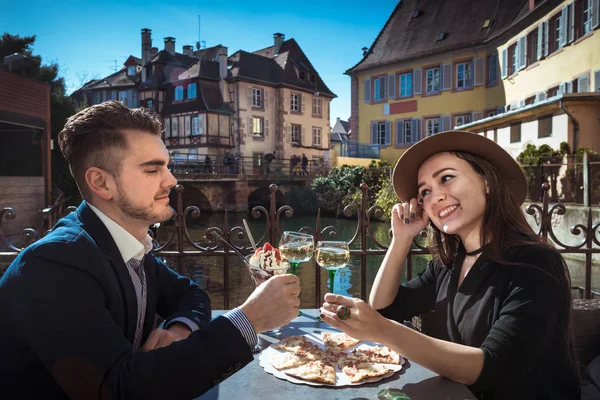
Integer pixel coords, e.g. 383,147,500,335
0,102,300,399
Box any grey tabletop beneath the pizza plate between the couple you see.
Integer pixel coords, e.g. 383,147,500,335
197,309,475,400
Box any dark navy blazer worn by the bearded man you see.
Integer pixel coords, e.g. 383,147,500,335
0,202,252,399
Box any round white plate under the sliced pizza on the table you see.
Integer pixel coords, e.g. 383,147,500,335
258,332,404,387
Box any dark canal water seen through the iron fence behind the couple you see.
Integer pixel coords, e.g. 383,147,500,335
158,213,600,309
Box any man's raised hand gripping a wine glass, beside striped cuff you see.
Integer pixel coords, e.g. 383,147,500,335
240,274,300,333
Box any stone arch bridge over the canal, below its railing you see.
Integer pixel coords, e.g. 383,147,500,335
171,172,314,212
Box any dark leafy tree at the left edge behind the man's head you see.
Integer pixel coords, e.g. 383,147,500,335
0,33,80,203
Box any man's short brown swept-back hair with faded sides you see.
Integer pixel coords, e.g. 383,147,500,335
58,101,162,199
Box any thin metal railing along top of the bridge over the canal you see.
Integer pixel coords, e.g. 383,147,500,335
170,154,329,177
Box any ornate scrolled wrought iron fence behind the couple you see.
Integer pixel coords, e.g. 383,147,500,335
0,183,600,309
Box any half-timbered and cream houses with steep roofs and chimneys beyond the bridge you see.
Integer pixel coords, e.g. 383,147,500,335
73,29,335,173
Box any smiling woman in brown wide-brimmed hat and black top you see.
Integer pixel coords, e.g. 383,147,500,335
322,131,579,399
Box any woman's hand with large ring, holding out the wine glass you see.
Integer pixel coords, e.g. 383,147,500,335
321,293,387,342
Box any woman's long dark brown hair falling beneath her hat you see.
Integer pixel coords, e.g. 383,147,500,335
429,151,576,378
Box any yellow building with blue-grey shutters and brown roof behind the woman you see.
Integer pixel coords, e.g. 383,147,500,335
346,0,600,162
